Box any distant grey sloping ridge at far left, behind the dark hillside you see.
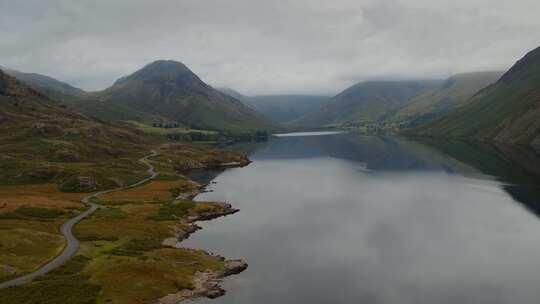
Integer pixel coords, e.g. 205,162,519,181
4,69,87,100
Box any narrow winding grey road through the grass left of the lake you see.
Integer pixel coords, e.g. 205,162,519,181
0,150,159,289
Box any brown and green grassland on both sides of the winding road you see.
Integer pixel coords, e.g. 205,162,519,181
0,143,246,304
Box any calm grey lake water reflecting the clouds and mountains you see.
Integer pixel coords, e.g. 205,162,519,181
184,134,540,304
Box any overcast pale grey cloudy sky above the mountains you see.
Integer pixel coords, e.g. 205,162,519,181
0,0,540,95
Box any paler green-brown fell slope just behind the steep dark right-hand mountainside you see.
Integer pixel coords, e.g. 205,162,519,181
387,71,503,128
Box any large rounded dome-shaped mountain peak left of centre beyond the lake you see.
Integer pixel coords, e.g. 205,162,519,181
75,60,273,132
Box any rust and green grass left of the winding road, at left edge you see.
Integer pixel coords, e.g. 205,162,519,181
0,184,83,280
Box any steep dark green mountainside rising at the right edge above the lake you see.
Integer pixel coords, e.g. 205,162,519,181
413,47,540,145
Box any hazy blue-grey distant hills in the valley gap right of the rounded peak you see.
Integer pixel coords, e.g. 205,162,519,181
219,88,328,125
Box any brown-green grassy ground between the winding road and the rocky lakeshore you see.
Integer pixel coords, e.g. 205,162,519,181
70,180,229,304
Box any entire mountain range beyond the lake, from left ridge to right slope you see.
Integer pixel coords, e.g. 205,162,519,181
3,48,540,145
